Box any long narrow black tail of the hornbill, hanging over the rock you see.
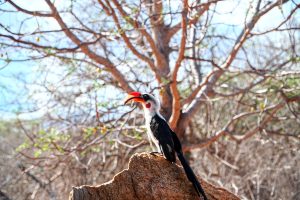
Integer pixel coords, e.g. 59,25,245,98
177,152,207,200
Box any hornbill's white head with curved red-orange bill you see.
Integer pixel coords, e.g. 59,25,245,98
124,92,160,116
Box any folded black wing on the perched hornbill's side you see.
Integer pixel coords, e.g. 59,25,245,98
150,115,176,162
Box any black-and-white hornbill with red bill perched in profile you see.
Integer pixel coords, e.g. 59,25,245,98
124,92,207,200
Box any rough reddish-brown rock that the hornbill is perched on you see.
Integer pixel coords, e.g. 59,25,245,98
69,153,239,200
